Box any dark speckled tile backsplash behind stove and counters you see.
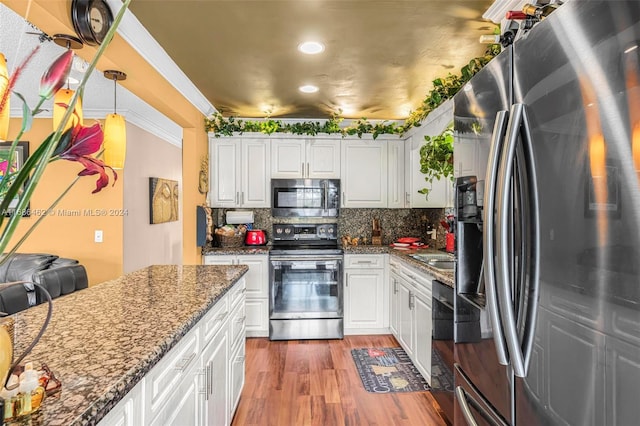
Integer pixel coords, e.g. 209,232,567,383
214,209,445,248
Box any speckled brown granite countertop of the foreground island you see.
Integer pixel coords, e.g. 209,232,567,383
14,265,248,426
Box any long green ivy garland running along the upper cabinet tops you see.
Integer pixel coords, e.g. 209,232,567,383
204,43,500,139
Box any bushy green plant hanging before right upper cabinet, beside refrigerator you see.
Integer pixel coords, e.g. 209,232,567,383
418,126,453,197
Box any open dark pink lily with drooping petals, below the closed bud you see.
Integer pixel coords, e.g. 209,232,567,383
54,123,118,194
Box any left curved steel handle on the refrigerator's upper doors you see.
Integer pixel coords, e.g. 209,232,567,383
483,111,509,365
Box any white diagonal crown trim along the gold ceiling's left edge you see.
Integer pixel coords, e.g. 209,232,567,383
107,0,216,116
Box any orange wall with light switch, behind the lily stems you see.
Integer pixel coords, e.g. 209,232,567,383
9,118,125,285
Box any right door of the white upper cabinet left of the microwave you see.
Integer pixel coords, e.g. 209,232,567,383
240,139,271,208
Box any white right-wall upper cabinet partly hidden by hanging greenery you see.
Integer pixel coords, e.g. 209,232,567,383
405,100,455,208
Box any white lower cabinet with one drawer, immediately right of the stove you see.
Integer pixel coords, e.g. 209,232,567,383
344,254,389,334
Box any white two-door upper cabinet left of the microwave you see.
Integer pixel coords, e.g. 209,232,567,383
209,137,271,208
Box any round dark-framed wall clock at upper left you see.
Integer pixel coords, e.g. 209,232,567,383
71,0,113,46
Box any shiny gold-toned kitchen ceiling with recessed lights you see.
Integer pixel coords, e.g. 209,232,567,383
129,0,494,119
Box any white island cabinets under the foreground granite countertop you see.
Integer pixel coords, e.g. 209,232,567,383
99,278,246,426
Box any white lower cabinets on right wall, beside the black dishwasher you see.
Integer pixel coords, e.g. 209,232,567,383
389,258,433,382
